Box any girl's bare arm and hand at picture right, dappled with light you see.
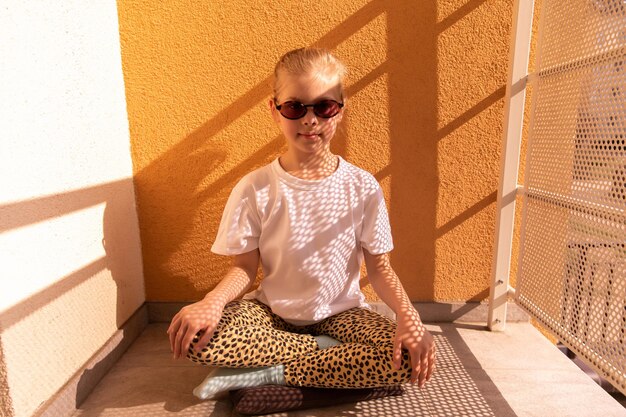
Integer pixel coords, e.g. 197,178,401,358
363,249,435,387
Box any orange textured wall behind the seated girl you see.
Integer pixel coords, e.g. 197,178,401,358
118,0,512,301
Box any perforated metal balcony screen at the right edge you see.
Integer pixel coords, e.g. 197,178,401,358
516,0,626,393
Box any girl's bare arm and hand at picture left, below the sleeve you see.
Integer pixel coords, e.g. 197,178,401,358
167,249,260,359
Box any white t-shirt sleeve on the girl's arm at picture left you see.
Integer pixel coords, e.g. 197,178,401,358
211,178,261,255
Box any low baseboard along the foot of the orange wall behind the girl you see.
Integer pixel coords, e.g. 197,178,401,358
146,302,529,325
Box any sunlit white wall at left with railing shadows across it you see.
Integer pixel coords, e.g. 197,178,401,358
0,1,145,417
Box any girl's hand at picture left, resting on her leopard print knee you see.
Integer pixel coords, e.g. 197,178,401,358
167,297,224,359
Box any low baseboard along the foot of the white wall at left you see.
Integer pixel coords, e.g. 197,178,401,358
34,303,148,417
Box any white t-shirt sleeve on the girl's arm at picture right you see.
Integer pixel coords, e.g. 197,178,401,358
361,183,393,255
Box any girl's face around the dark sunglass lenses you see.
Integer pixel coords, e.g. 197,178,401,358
270,74,343,156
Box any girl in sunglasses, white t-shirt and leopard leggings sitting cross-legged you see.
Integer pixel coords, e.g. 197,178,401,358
167,48,435,399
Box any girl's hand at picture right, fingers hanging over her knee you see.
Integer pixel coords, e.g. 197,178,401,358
393,310,435,388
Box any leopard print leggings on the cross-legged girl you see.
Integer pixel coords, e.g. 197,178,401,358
187,300,411,388
